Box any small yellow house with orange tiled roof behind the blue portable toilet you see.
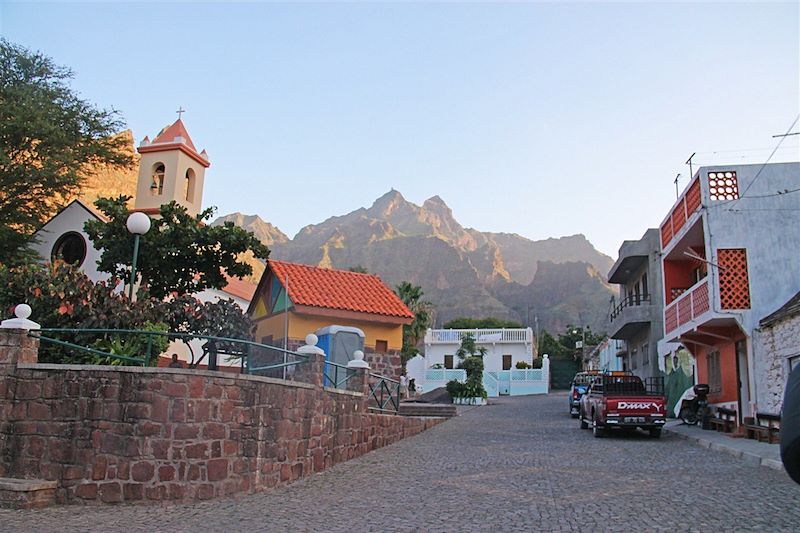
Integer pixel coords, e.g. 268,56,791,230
248,260,414,377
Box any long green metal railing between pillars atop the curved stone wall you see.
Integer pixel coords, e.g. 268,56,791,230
28,328,309,374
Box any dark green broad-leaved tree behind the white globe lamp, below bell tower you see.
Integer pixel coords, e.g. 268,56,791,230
85,196,269,298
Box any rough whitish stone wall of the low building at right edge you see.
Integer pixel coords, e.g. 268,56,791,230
754,315,800,413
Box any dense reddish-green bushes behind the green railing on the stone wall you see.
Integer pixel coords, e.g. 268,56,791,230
0,262,253,364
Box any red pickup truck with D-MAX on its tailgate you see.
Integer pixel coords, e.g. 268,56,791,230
579,372,667,438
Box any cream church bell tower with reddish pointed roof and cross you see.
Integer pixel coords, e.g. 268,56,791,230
133,110,211,216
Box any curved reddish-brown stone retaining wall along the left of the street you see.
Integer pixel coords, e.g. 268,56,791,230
0,329,442,503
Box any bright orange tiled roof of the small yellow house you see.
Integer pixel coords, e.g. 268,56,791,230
267,260,414,319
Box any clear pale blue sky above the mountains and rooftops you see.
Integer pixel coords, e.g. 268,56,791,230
0,2,800,258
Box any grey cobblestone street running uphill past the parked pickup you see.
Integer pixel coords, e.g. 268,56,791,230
0,393,800,533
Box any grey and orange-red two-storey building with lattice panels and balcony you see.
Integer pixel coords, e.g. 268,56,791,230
659,163,800,422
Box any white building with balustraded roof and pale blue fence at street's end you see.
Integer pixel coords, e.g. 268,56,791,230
406,328,549,396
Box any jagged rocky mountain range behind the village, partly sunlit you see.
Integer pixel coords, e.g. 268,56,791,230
214,190,614,332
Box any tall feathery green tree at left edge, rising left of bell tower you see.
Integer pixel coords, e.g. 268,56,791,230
0,39,132,264
